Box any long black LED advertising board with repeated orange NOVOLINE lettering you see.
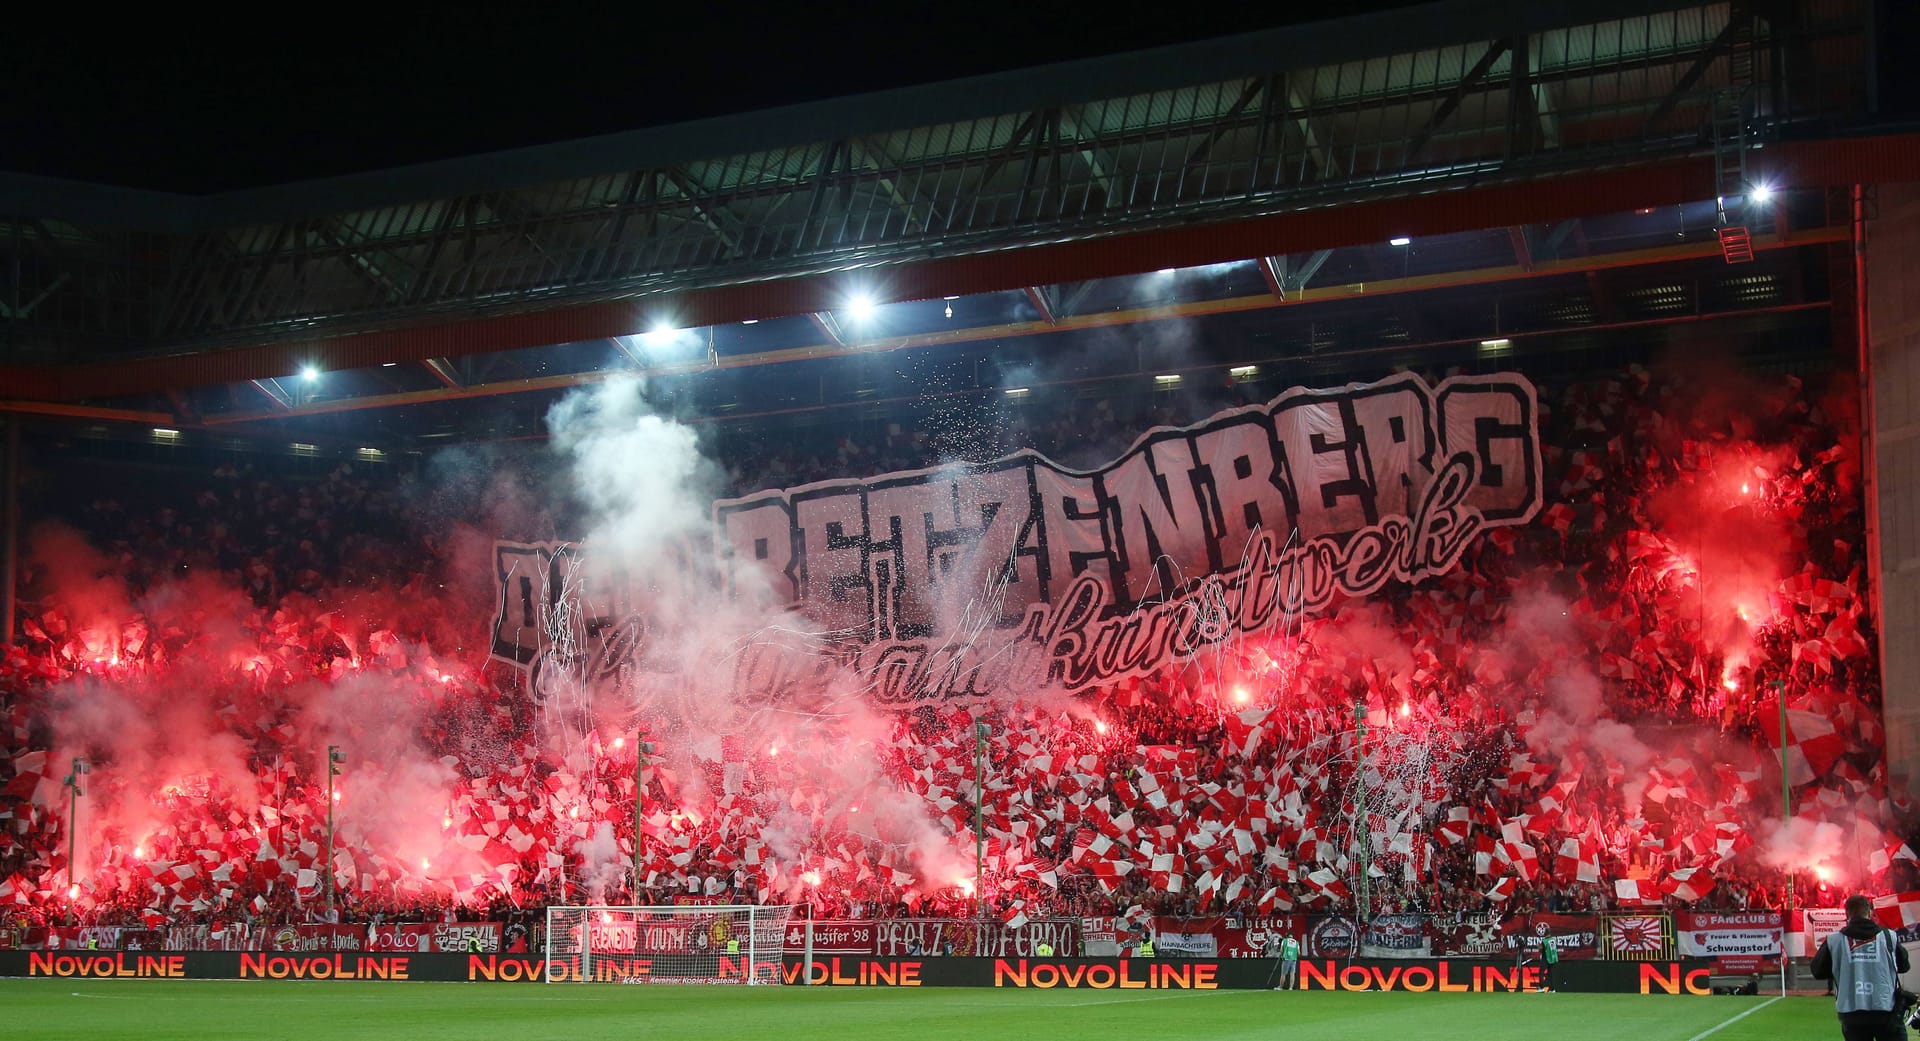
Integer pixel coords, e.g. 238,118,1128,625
0,951,1715,995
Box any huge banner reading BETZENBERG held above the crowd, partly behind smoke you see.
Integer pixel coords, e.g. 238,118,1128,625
492,373,1542,707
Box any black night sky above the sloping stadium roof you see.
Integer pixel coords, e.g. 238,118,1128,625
0,0,1404,192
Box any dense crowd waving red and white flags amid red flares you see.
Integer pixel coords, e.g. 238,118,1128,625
0,355,1916,941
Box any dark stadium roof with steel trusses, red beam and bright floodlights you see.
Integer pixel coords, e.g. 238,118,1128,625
0,0,1896,445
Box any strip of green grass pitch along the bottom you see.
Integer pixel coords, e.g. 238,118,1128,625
0,980,1839,1041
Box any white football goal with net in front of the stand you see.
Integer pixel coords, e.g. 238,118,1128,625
547,905,793,983
